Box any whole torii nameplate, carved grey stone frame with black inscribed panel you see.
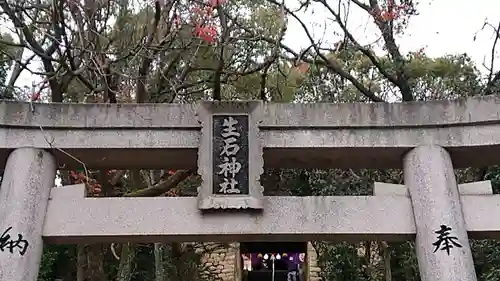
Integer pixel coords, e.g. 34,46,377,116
196,101,264,210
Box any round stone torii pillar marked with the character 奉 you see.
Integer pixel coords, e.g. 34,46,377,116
404,145,477,281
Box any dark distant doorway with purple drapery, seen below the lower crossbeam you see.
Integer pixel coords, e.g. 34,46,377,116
240,242,307,281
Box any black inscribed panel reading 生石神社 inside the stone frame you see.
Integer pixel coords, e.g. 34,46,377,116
212,115,249,195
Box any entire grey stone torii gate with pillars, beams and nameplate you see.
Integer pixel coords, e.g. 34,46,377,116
0,96,500,281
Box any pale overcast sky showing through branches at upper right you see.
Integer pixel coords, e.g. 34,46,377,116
285,0,500,73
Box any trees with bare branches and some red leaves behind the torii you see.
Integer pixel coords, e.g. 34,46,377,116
0,0,500,281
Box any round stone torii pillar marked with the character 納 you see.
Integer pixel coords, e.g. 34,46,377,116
0,148,56,281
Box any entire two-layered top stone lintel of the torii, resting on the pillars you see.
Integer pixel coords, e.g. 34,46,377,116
4,96,500,169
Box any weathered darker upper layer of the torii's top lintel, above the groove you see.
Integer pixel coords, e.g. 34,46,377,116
0,95,500,129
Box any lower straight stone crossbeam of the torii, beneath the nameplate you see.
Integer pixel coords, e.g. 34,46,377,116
43,185,500,244
